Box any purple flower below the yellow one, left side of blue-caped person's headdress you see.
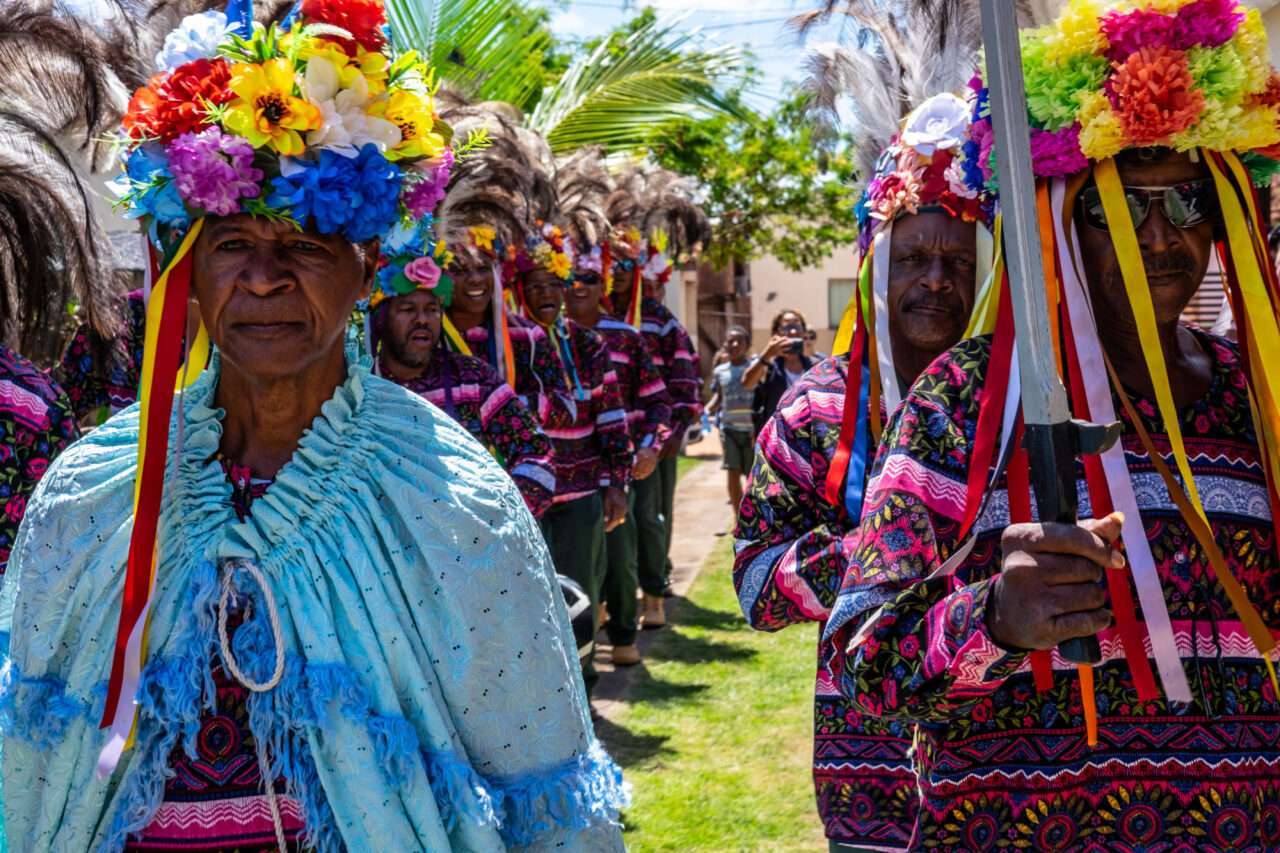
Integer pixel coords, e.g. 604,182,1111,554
168,127,262,216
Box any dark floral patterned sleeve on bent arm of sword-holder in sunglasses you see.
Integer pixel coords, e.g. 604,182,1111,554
827,342,1028,724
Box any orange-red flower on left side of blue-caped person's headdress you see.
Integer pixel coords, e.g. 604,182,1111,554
124,59,236,142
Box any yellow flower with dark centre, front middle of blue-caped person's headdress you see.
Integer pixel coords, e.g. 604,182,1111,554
224,59,324,156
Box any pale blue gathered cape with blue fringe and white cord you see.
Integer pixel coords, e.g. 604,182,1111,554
0,348,626,852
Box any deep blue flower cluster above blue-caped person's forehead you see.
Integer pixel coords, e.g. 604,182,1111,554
266,145,401,243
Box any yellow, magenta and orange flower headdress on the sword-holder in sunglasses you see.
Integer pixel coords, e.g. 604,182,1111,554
970,0,1280,187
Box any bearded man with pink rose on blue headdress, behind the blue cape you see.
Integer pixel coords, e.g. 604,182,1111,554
370,222,556,519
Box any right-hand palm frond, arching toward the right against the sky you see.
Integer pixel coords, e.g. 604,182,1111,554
529,20,750,154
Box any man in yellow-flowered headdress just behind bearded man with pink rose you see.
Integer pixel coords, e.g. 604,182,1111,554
515,224,634,694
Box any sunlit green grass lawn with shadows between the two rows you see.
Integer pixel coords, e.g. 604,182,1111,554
598,537,826,853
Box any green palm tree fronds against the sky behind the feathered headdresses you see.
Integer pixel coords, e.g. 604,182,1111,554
387,0,750,155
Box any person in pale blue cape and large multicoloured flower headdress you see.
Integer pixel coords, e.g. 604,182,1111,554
0,0,626,850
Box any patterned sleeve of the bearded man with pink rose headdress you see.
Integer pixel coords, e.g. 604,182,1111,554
480,375,556,519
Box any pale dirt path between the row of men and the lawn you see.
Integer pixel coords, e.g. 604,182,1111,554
591,445,732,720
